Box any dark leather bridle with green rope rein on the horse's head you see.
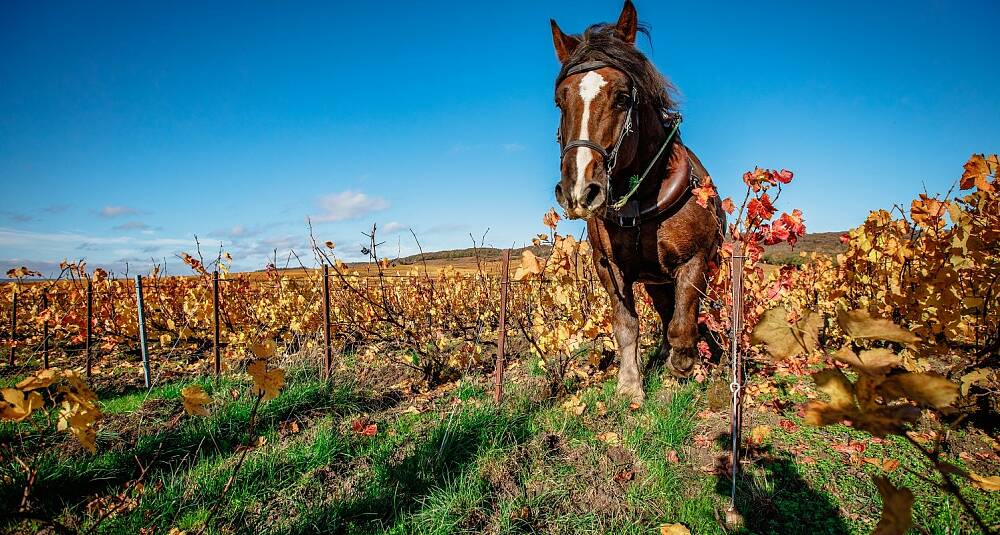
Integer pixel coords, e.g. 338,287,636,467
556,61,681,216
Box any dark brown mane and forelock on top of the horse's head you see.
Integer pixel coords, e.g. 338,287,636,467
556,23,677,110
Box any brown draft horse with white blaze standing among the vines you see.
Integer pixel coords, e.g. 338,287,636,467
551,0,725,402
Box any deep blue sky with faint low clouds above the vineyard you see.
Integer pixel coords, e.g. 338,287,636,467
0,0,1000,273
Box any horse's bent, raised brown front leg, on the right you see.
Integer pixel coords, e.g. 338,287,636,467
667,255,707,377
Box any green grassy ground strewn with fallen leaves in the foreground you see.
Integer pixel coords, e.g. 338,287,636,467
0,362,1000,534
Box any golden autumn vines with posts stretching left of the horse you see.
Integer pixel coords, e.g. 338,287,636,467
0,242,628,399
